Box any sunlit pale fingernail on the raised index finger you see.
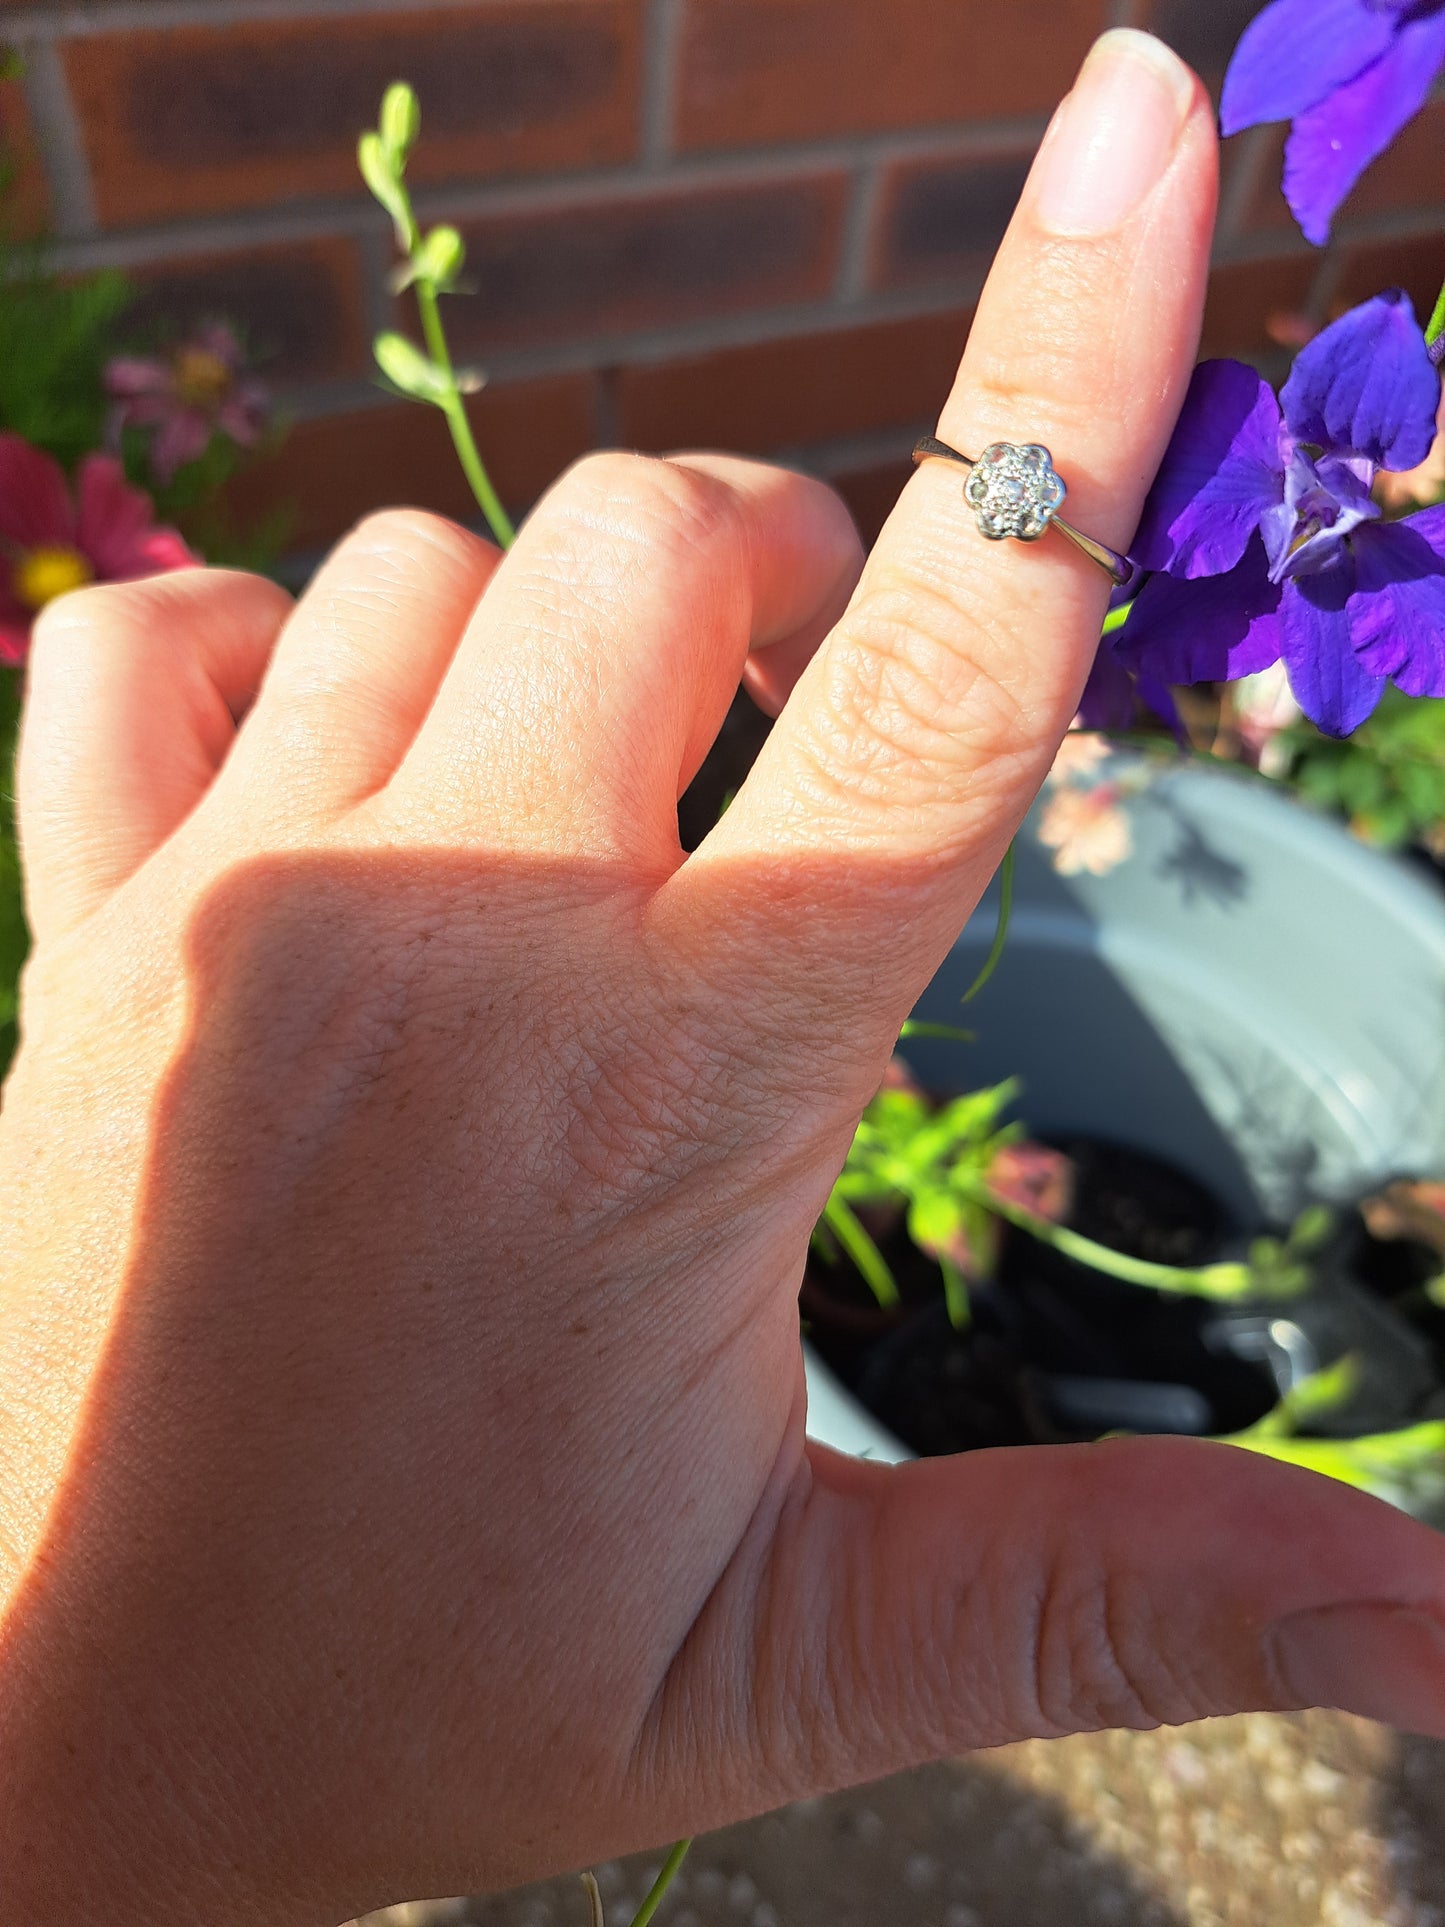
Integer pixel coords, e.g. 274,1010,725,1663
1033,27,1196,239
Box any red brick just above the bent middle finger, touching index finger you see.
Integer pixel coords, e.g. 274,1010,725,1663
617,310,971,455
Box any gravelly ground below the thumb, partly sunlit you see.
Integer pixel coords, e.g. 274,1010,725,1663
350,1713,1445,1927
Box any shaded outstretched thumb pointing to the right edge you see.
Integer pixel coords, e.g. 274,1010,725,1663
669,1438,1445,1825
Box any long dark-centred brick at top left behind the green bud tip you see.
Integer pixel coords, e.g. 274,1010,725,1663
64,0,642,225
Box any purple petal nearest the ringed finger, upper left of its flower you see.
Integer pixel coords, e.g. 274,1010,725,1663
1129,360,1285,578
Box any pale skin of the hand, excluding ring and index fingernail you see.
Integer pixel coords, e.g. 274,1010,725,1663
0,33,1445,1927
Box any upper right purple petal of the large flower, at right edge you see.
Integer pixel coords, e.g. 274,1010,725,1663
1279,287,1439,468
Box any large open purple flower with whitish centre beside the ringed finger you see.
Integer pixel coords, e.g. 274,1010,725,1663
1112,291,1445,736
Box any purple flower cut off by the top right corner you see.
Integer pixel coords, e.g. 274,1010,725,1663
1220,0,1445,247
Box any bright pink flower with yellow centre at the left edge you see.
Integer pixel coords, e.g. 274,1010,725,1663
0,434,200,669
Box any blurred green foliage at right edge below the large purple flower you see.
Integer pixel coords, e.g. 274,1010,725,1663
1279,688,1445,858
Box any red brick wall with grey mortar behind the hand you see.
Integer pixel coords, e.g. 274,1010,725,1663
0,0,1445,549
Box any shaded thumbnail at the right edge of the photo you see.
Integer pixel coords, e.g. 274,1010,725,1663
1274,1605,1445,1738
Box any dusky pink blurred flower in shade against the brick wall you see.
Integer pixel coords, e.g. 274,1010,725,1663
106,322,270,484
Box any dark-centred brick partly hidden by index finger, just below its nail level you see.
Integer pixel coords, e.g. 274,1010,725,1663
873,154,1033,287
